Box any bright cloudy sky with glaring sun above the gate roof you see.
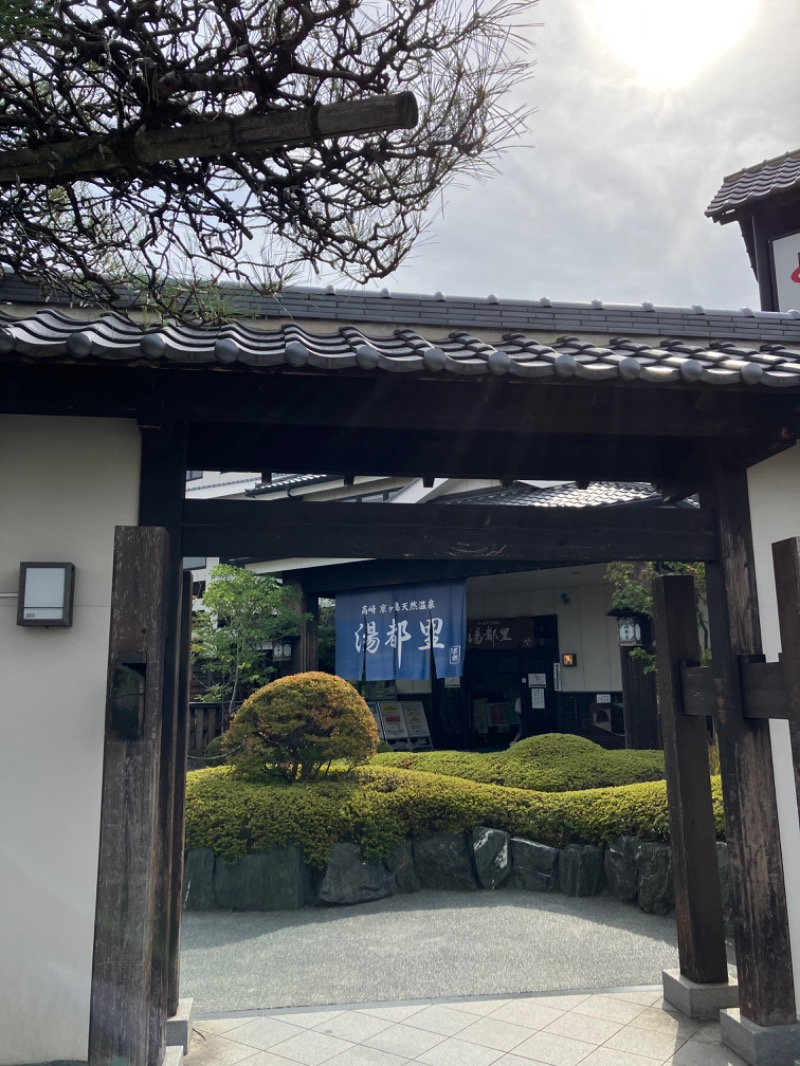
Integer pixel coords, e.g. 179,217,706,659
373,0,800,308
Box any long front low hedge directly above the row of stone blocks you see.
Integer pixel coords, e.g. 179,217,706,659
186,766,722,868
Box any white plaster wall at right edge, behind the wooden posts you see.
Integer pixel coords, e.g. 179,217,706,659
748,446,800,1006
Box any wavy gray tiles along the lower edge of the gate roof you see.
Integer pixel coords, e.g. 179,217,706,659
0,308,800,387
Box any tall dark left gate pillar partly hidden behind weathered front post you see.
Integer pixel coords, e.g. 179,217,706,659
139,422,187,1066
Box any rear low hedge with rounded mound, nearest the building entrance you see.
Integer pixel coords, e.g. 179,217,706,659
372,733,663,792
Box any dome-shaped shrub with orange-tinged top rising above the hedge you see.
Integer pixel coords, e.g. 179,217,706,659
222,673,378,781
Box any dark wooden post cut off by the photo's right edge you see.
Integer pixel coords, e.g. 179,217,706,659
772,536,800,804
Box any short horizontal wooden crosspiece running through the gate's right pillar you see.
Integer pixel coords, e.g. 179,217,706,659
681,657,789,718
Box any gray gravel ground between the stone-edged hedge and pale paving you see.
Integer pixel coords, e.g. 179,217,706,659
180,890,691,1013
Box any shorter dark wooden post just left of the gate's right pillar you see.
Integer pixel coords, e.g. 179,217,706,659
653,575,727,984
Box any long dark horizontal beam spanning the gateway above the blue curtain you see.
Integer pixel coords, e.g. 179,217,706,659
182,500,716,564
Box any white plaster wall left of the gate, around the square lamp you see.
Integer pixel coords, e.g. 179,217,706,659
0,416,140,1066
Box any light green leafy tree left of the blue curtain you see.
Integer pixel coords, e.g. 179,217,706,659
192,564,307,715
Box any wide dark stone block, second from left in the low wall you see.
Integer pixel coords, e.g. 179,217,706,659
214,844,315,910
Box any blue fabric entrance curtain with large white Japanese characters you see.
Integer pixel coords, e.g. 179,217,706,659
336,581,466,681
